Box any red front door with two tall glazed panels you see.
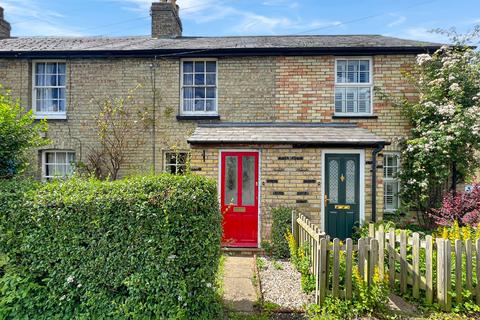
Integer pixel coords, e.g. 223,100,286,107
221,152,258,247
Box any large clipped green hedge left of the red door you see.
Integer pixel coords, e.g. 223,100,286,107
0,175,221,319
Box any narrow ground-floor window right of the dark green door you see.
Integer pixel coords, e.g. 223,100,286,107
383,153,400,212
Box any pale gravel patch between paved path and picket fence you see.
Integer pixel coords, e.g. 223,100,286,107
259,257,314,310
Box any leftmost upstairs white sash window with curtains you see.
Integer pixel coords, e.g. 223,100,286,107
33,62,66,119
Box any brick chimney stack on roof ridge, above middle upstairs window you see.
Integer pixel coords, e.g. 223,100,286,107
150,0,182,38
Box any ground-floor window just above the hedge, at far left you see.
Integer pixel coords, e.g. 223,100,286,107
43,151,75,180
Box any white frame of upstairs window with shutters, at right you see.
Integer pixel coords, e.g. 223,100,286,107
333,56,373,117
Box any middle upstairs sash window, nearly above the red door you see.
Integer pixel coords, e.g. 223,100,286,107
181,60,218,115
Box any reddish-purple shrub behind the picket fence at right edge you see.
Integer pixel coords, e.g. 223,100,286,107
430,183,480,226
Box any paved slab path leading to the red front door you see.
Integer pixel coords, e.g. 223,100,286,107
223,256,258,313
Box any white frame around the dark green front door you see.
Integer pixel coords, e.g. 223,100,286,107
320,149,365,232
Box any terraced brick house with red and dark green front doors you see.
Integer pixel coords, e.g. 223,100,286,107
0,0,440,247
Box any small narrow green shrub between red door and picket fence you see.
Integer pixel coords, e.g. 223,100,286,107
271,207,292,259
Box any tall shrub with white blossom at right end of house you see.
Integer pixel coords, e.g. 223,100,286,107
400,35,480,220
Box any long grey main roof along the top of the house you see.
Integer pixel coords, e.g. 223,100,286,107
0,35,441,56
